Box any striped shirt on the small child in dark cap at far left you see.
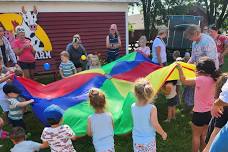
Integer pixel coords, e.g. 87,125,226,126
8,98,23,120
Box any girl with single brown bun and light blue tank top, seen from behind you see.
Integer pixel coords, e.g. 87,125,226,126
87,88,115,152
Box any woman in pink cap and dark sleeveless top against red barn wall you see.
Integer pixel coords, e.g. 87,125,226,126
106,24,121,62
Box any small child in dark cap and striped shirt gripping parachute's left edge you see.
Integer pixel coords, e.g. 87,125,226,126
3,83,34,130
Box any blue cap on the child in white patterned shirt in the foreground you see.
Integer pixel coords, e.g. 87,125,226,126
44,104,64,121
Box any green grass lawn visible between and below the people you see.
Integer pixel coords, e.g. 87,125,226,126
0,58,228,152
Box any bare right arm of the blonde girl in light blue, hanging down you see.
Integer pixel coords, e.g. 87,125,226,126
150,107,167,140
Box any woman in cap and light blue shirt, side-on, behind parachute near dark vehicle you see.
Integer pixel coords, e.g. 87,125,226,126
152,26,168,66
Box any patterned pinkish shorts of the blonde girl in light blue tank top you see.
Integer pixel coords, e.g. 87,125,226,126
134,140,156,152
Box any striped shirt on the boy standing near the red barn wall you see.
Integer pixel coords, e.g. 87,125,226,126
59,60,76,77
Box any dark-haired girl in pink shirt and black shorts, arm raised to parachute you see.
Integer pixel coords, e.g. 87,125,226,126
177,57,219,152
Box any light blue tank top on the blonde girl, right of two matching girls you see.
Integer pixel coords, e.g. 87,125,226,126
131,103,156,144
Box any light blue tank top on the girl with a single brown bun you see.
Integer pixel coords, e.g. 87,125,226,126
90,112,114,151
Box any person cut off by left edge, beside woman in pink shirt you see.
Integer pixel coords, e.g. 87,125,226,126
0,25,17,66
